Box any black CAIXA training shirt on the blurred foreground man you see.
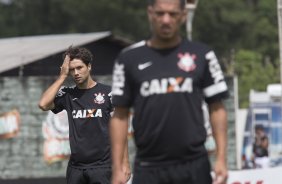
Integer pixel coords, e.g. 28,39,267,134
112,40,228,163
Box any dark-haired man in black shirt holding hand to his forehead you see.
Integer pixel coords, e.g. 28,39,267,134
39,47,130,184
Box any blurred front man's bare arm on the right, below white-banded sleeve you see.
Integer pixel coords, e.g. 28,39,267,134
209,102,228,184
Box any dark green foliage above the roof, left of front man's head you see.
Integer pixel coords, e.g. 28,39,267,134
0,0,149,39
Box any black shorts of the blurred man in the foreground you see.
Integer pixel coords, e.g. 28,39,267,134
132,156,212,184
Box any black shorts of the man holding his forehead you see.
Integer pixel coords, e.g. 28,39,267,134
66,166,112,184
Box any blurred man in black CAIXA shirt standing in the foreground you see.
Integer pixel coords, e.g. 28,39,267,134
110,0,228,184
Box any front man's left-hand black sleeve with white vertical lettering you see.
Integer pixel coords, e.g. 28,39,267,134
112,55,132,107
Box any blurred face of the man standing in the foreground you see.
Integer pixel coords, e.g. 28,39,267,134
147,0,186,40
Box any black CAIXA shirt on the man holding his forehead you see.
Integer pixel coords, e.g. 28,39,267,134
52,83,113,168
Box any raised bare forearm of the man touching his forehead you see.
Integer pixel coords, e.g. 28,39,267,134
38,75,66,111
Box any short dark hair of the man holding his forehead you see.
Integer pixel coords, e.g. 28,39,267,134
63,46,93,65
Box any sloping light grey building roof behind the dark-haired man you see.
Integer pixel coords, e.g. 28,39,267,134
0,31,111,73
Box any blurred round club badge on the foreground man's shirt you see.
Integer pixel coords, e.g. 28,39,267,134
177,52,196,72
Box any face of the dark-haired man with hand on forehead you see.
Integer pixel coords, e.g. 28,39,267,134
69,59,91,85
